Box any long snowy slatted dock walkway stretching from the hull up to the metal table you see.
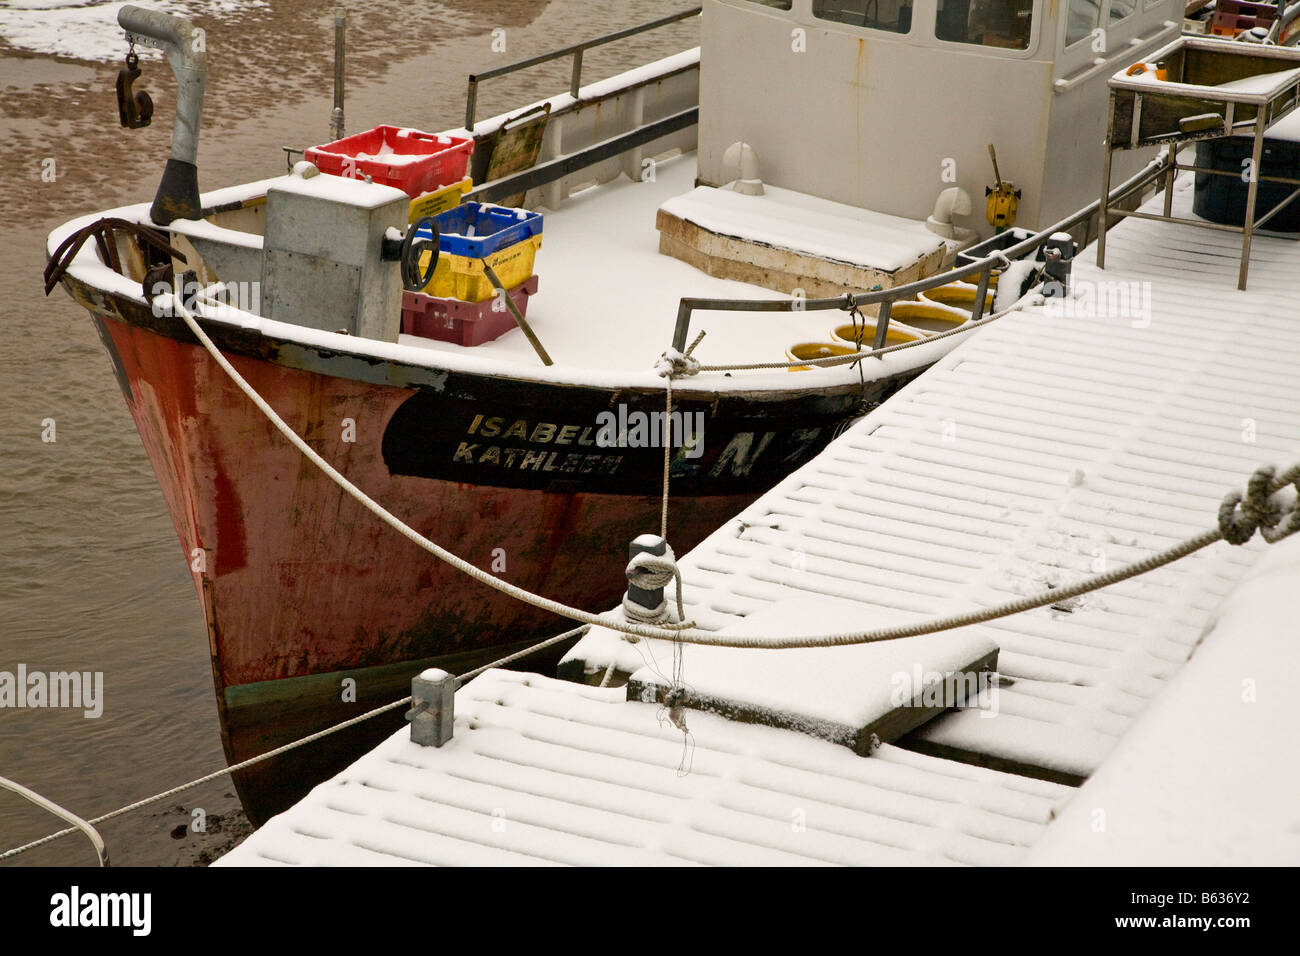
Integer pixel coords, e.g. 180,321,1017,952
569,179,1300,782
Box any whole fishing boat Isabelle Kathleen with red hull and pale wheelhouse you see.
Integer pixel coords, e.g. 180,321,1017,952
47,0,1183,821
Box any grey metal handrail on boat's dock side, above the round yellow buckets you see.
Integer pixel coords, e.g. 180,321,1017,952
672,150,1170,351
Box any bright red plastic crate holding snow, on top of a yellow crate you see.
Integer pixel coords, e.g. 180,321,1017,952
306,126,475,199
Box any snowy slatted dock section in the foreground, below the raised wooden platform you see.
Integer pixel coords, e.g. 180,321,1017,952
217,670,1070,866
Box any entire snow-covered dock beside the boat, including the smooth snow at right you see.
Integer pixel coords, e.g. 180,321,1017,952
215,174,1300,864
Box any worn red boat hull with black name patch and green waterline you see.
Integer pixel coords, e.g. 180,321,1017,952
68,280,920,822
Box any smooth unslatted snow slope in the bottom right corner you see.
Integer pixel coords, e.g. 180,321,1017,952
1027,535,1300,866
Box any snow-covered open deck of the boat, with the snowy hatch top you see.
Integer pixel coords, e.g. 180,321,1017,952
399,152,950,374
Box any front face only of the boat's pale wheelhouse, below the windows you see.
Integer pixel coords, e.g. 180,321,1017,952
699,0,1052,228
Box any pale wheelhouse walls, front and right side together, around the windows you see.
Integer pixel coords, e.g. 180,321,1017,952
699,0,1182,234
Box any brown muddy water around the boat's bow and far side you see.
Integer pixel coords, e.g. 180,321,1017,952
0,0,698,865
